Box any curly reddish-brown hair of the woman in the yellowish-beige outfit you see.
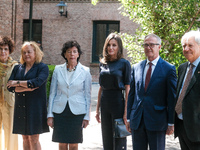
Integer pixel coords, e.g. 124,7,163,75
0,36,15,54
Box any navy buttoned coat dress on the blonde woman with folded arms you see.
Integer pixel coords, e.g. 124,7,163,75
8,63,49,135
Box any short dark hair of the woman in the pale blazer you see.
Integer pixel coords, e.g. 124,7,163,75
61,40,83,62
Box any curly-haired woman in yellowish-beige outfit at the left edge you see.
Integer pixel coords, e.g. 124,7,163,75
0,36,18,150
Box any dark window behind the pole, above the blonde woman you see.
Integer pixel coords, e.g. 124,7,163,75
23,20,42,43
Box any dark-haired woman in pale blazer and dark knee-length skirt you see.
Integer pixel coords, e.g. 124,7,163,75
47,41,92,150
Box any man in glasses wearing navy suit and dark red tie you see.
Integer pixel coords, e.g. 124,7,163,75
127,34,177,150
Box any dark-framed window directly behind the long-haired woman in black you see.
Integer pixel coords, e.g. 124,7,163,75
92,21,119,63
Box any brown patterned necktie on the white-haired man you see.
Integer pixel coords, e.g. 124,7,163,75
175,64,194,114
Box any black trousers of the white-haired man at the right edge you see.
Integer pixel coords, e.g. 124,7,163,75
177,119,200,150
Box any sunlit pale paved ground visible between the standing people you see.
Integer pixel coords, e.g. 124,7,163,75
1,84,180,150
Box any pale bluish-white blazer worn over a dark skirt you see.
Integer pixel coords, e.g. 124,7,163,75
47,62,92,120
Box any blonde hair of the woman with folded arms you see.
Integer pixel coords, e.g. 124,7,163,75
20,41,44,64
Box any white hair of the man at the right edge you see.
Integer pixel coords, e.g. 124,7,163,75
181,30,200,45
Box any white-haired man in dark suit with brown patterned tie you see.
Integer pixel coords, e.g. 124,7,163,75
175,31,200,150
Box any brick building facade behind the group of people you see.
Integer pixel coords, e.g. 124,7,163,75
0,0,138,82
